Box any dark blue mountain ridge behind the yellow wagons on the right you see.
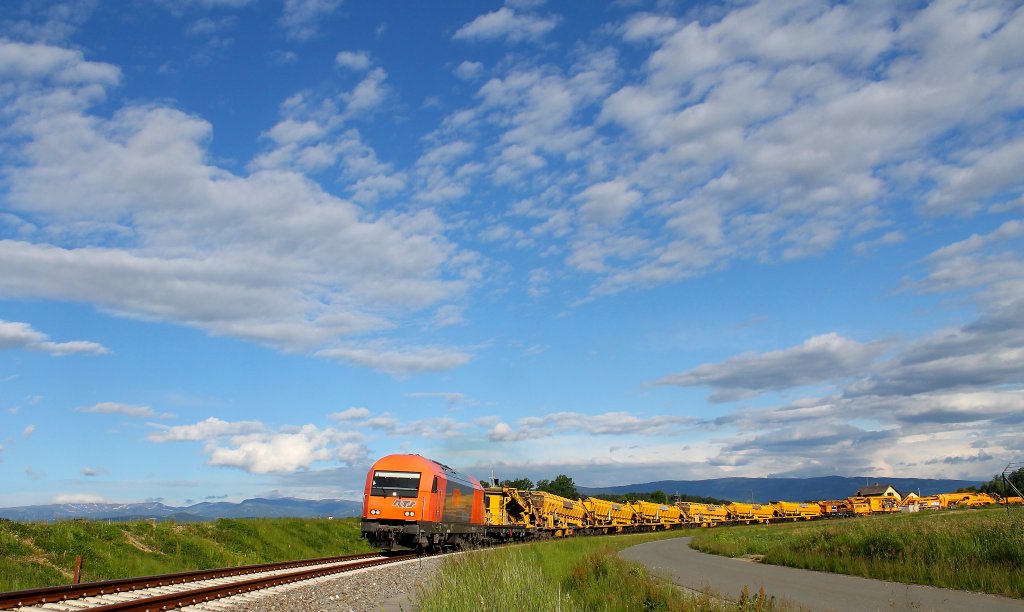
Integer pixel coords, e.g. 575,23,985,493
577,476,981,502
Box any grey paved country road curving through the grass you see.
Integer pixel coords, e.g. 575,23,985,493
620,537,1024,612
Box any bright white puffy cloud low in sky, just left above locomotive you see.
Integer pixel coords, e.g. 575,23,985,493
147,417,370,474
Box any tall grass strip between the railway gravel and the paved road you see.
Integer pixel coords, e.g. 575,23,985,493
417,531,778,612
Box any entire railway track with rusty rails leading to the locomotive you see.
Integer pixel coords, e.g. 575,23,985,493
0,553,416,612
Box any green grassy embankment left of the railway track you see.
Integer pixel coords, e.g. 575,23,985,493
0,519,373,592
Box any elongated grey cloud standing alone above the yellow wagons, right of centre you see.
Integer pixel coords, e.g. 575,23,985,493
653,334,888,401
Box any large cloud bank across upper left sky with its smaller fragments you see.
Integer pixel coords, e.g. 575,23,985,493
0,38,468,370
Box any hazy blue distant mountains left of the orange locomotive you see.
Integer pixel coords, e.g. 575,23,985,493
0,497,362,523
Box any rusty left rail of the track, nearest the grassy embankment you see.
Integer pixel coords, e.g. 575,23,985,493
0,553,380,610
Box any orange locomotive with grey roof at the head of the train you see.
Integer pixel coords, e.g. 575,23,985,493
362,454,484,551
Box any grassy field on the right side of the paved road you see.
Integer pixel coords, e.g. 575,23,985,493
690,509,1024,598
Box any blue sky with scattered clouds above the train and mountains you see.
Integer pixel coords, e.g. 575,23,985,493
0,0,1024,506
